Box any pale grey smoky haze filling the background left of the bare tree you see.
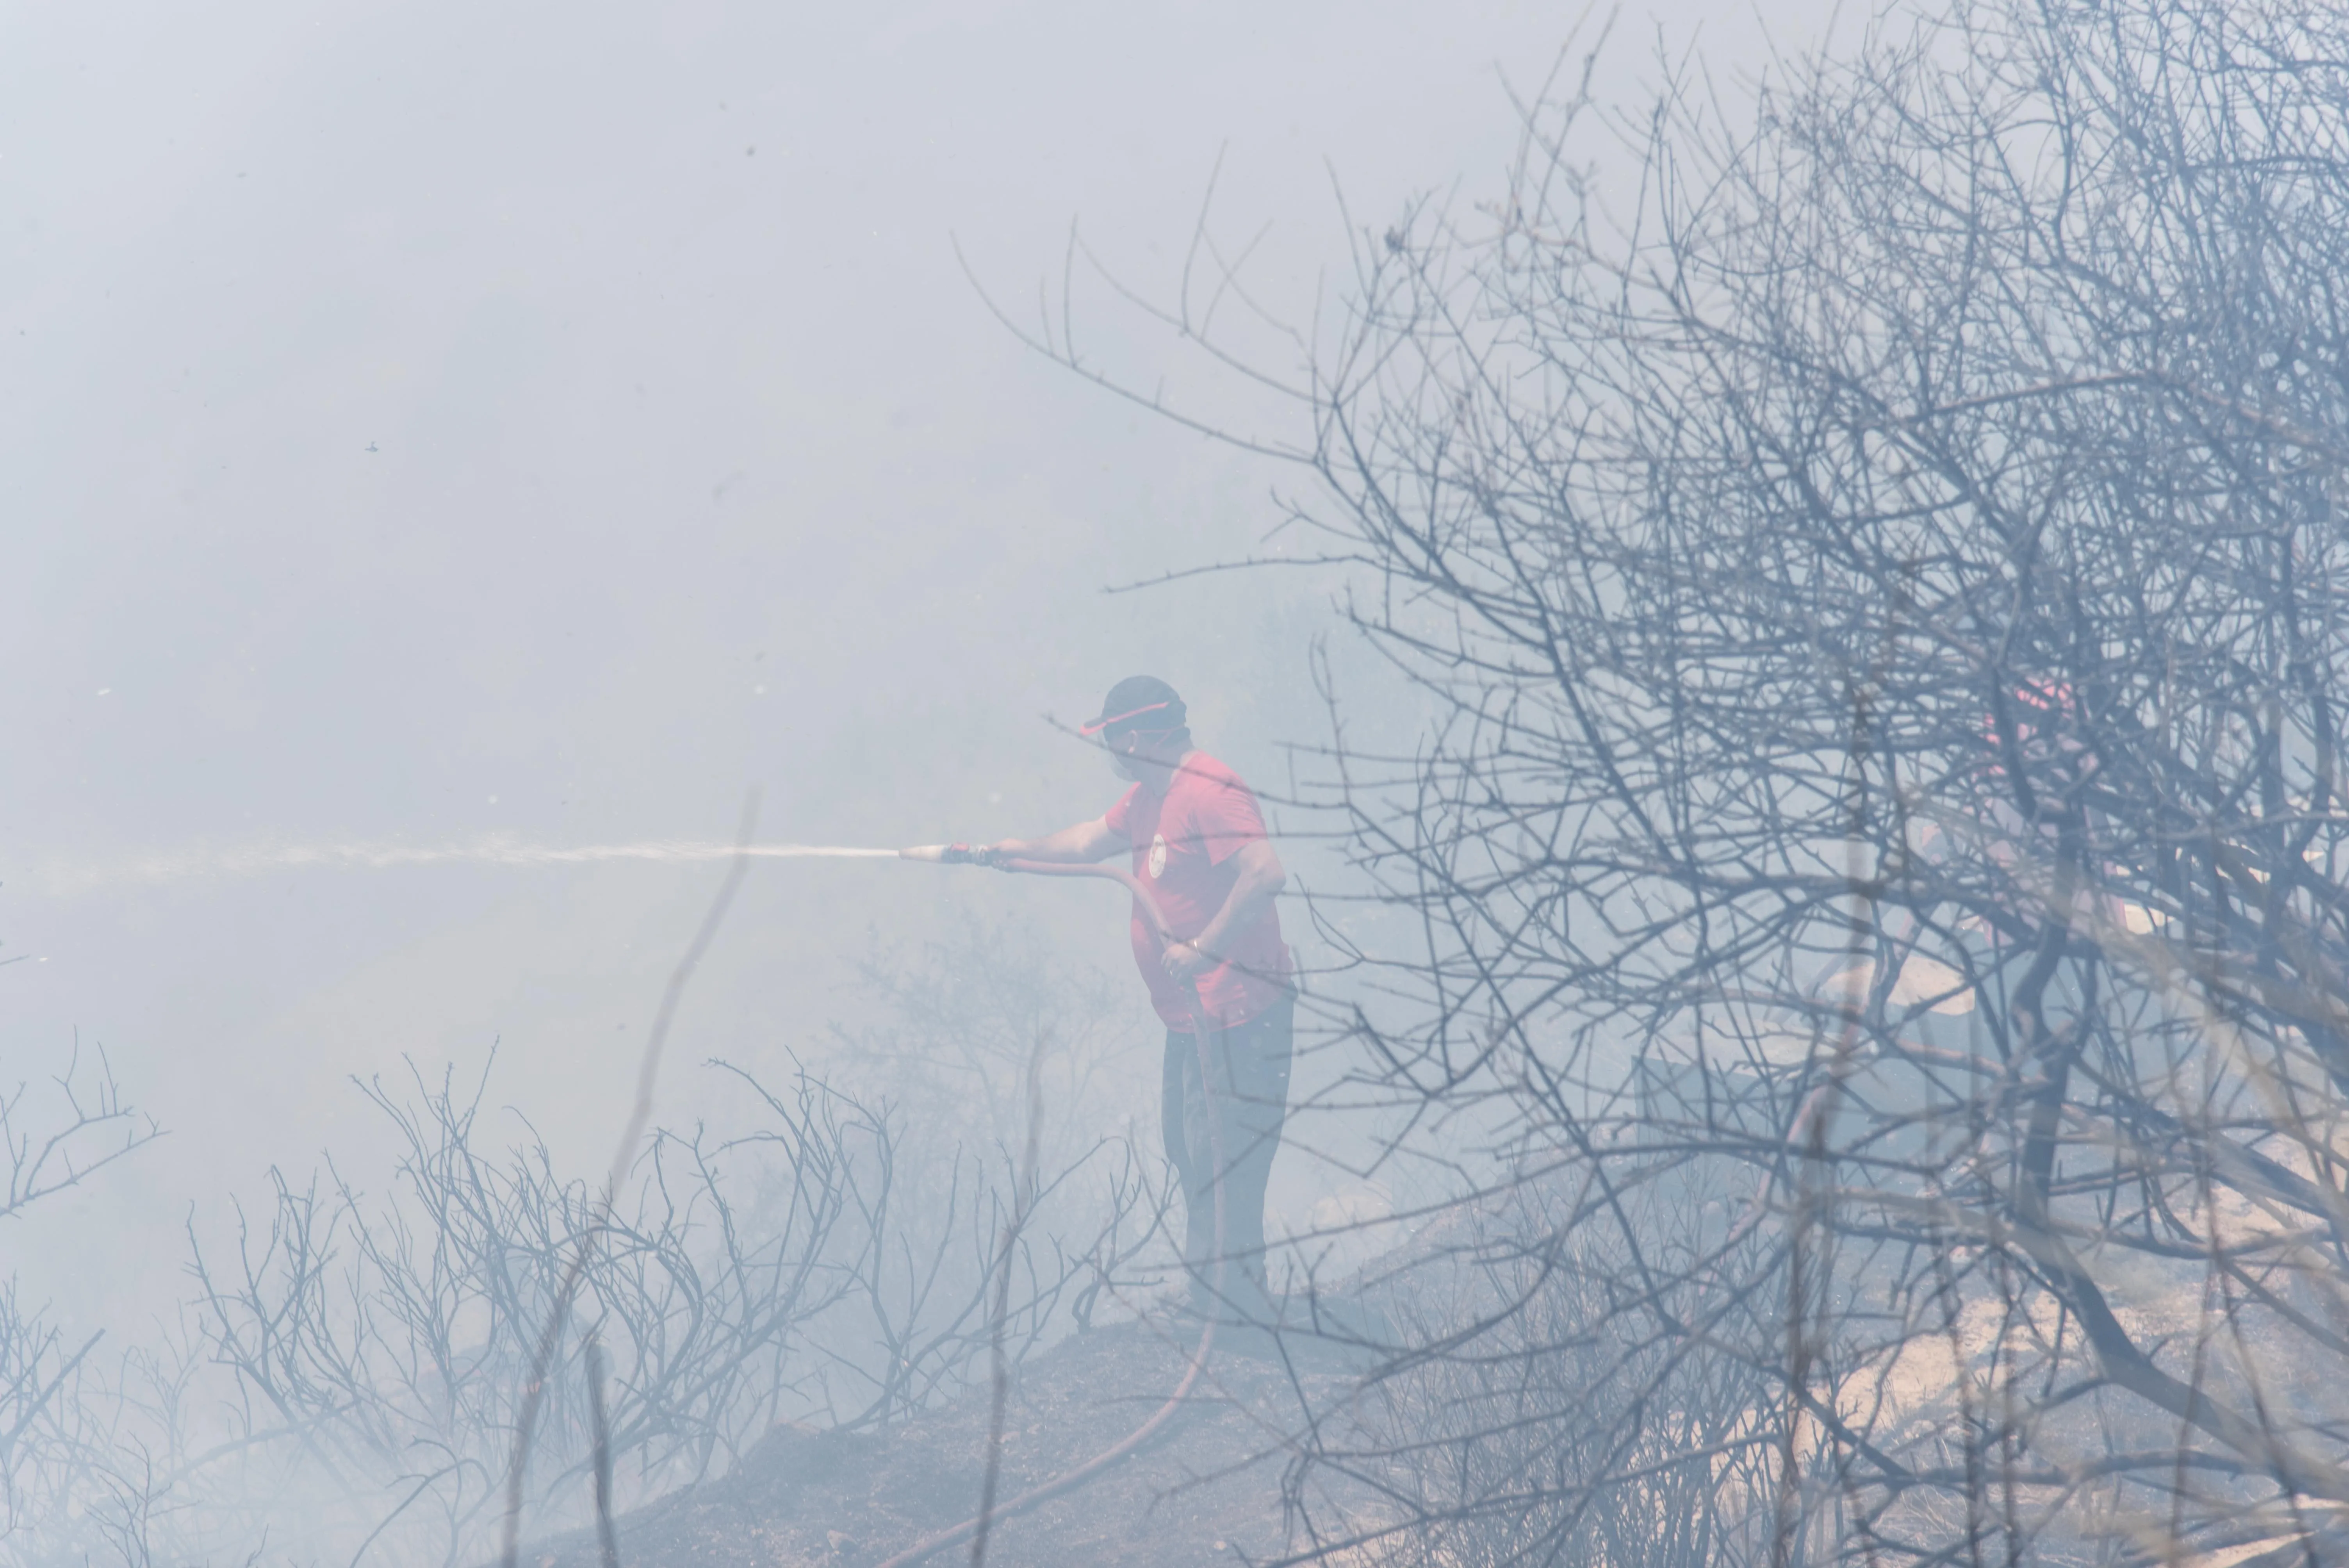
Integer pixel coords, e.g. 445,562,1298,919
0,0,1825,1305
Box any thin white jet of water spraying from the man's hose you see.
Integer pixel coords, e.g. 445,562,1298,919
26,833,897,897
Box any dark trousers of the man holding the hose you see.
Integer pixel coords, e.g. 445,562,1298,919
1160,995,1297,1310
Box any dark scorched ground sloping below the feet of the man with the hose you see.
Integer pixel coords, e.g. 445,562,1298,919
522,1322,1381,1568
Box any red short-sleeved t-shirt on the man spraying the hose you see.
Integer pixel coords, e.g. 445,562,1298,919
1102,751,1290,1028
